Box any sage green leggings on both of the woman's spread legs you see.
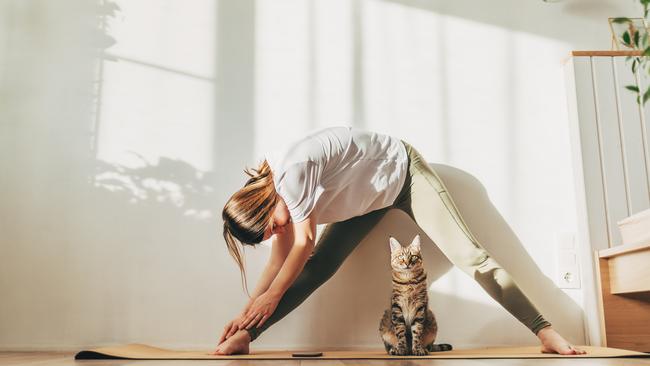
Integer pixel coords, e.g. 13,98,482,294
248,143,550,340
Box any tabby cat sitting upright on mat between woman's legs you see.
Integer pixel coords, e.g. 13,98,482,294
379,235,452,356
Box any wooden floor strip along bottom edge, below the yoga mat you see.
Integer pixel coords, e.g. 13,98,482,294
0,352,650,366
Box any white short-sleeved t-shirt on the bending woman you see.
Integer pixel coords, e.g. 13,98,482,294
266,127,408,224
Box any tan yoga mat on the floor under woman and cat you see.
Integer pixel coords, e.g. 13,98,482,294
75,344,650,360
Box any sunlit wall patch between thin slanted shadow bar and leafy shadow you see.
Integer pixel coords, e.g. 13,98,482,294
97,61,213,170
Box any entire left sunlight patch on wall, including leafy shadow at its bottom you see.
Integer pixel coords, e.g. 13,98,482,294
93,0,217,219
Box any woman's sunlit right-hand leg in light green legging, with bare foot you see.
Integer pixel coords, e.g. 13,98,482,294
396,145,575,353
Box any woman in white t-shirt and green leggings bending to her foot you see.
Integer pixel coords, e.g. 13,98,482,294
215,127,584,354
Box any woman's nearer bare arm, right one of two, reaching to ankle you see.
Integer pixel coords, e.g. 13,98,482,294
240,217,316,329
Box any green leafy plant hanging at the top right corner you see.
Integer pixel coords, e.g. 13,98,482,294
610,0,650,106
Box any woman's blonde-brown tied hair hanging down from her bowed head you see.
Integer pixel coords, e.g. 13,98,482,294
222,160,278,292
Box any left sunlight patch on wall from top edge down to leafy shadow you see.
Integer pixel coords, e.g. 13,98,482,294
97,0,216,171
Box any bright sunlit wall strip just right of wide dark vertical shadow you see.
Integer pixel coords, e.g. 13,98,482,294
253,0,311,157
